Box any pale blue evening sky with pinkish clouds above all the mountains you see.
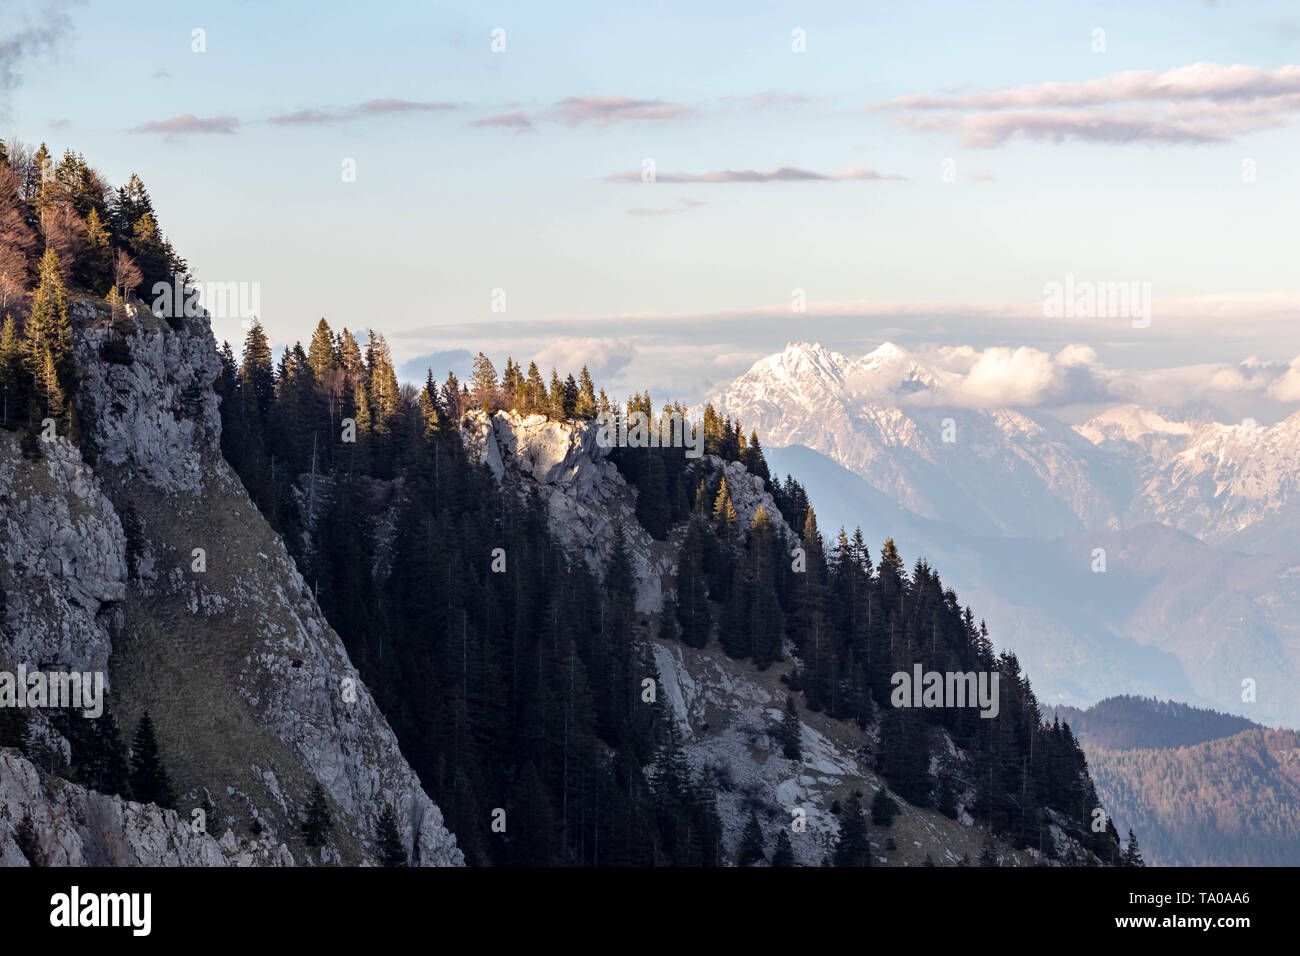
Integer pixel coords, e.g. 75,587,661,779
0,0,1300,420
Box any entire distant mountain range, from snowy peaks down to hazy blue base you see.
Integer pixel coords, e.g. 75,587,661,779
710,343,1300,726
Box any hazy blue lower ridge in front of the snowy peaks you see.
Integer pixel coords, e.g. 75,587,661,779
764,446,1300,726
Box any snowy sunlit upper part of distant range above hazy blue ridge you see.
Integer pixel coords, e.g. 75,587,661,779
707,342,1300,553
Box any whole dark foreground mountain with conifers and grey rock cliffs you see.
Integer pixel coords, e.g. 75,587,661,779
0,152,1123,866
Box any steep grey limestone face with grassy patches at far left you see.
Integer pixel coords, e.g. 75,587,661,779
0,300,464,865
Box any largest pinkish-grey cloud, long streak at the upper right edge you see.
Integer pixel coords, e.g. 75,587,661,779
868,62,1300,148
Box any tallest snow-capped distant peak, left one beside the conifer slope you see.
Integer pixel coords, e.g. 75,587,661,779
709,342,1130,537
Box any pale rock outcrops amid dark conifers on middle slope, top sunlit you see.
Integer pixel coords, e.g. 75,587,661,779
464,412,1096,866
